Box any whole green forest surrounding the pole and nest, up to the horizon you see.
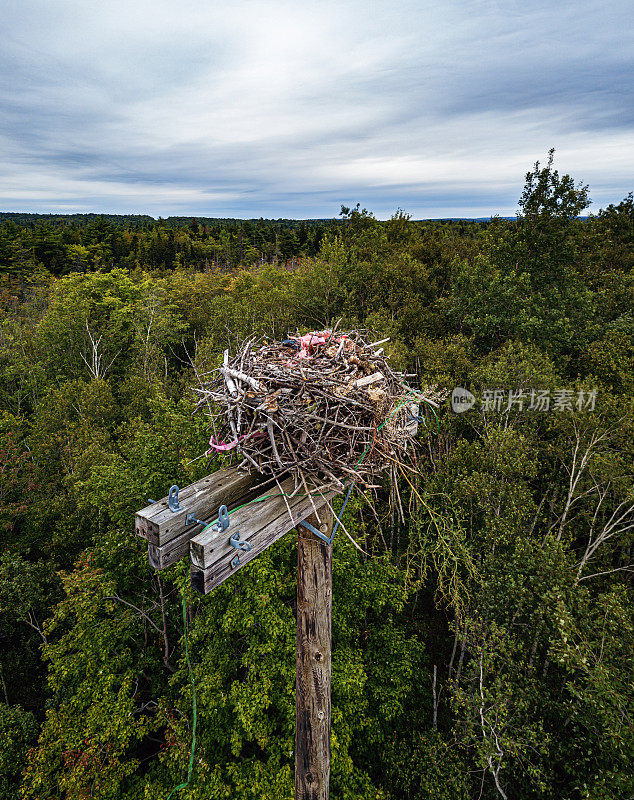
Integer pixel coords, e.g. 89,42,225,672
0,154,634,800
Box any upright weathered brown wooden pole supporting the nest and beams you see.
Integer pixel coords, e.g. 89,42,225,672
295,507,333,800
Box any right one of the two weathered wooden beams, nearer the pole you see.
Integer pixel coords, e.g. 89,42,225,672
190,478,337,594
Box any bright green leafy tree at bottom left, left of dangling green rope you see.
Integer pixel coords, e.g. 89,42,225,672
22,557,158,800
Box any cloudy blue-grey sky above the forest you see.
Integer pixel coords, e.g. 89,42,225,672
0,0,634,219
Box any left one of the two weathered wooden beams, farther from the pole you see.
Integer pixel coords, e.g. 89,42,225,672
135,467,263,547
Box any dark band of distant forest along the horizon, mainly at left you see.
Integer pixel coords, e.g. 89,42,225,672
0,209,482,281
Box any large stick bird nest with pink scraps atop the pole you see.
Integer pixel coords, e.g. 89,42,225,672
195,330,446,488
